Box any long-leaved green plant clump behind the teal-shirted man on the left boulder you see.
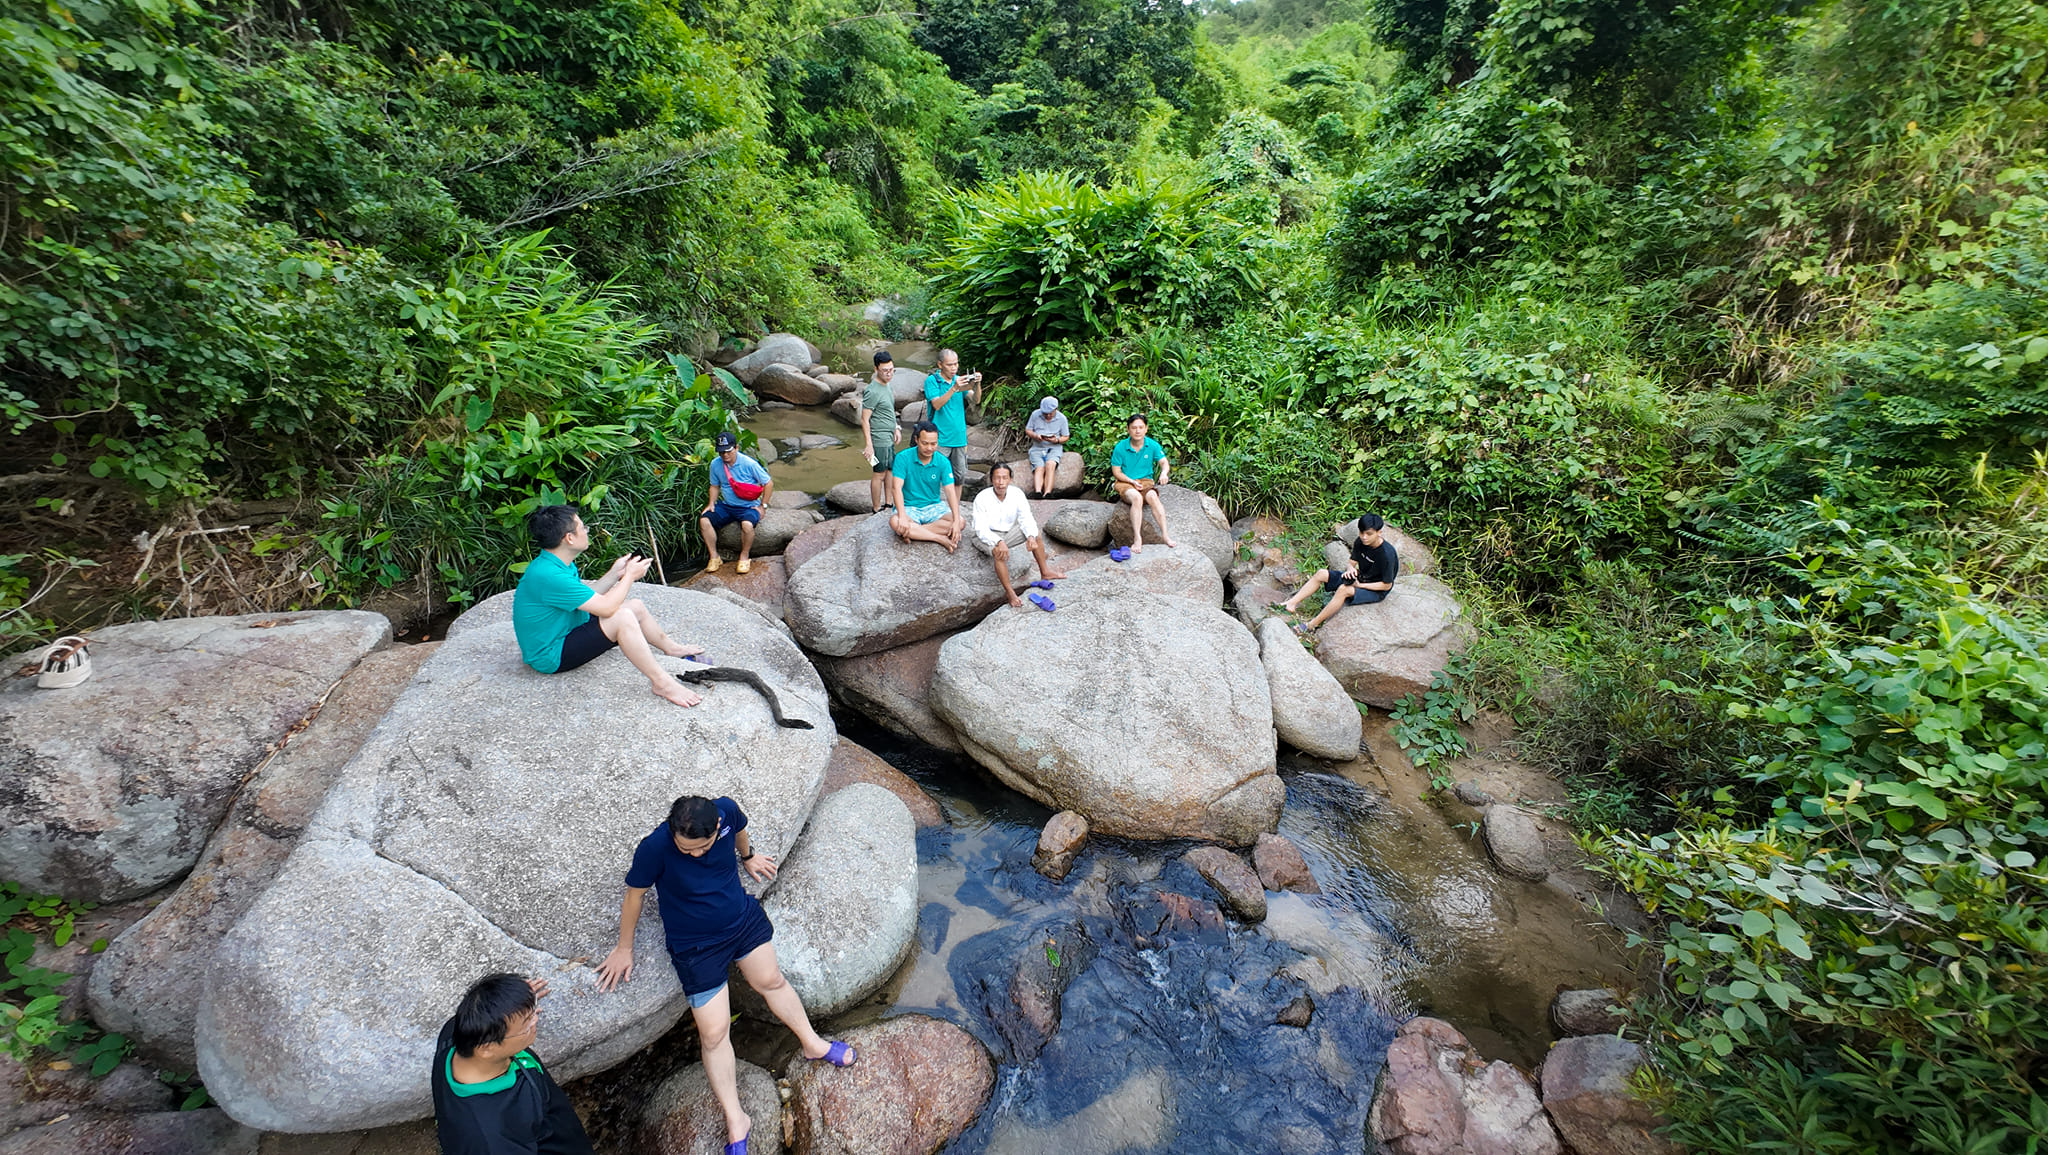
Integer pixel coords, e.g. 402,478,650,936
319,233,743,602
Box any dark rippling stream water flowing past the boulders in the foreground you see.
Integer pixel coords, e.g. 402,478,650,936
790,719,1622,1155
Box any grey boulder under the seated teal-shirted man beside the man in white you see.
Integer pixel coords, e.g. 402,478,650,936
788,508,1032,657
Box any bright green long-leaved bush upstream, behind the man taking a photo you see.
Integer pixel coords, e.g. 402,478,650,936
932,172,1260,365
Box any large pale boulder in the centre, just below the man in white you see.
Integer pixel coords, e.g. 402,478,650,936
932,581,1286,846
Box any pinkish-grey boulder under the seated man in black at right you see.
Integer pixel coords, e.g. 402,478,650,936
1315,578,1473,709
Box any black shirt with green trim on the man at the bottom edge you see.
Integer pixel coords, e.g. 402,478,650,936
430,1018,592,1155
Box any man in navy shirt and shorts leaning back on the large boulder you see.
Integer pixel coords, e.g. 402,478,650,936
598,795,854,1155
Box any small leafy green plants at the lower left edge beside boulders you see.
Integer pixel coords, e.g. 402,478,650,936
0,881,129,1077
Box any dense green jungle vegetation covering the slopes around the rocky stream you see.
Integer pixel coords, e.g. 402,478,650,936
0,0,2048,1155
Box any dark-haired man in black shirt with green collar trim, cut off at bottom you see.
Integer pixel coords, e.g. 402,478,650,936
432,975,592,1155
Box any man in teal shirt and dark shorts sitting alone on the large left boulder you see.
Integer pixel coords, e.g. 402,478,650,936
512,506,702,707
